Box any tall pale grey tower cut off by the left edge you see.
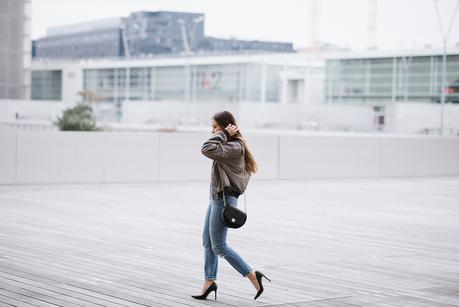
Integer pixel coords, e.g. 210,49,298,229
0,0,31,99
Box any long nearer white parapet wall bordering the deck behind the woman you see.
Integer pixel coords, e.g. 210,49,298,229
0,131,459,184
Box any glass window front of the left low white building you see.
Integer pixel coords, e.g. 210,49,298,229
83,63,294,102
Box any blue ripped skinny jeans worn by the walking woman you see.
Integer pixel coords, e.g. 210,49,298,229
202,196,252,280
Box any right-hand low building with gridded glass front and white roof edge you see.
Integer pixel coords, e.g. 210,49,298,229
324,47,459,104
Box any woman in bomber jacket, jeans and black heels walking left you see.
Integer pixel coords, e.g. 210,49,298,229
192,111,270,299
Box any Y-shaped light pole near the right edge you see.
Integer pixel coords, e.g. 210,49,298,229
433,0,459,135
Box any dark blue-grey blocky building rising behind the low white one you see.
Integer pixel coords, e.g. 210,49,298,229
34,11,293,58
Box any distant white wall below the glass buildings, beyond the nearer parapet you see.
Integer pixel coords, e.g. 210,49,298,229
4,100,459,135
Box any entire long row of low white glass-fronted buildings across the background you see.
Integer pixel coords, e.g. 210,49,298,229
32,49,459,105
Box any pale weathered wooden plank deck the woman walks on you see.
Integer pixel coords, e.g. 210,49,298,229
0,178,459,307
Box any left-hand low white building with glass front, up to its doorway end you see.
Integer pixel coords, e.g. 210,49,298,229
32,54,324,104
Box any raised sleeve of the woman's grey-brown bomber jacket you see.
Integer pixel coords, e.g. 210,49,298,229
201,130,243,160
